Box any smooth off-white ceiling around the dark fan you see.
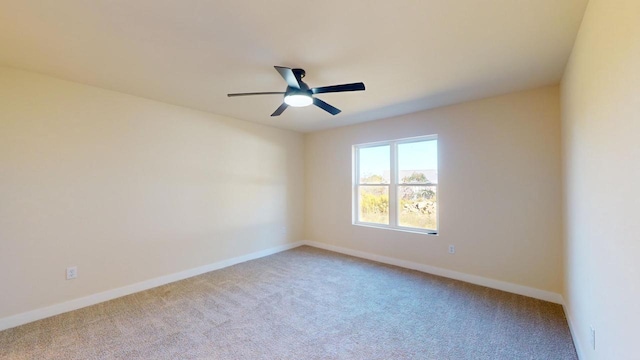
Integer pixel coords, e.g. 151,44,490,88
0,0,587,132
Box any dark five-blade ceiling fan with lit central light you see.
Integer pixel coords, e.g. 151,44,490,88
227,66,364,116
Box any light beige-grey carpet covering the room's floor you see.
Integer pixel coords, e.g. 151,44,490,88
0,246,577,360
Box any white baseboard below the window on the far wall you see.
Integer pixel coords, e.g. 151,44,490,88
302,240,563,304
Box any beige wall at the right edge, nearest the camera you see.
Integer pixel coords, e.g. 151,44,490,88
561,0,640,360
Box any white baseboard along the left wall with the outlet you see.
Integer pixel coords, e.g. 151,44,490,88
0,242,303,331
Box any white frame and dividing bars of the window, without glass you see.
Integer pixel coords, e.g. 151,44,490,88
351,134,440,236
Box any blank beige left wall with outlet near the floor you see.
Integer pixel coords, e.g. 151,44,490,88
0,68,304,319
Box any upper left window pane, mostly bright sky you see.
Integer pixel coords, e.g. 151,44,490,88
358,145,391,184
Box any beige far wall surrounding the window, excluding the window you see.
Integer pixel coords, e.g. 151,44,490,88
305,87,562,293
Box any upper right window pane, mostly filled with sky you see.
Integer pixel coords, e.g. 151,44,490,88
398,140,438,184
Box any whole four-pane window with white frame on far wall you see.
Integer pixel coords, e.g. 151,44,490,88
353,135,438,234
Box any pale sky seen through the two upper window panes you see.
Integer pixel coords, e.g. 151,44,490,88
360,140,438,177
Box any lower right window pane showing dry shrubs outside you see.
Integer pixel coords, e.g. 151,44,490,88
398,186,438,230
